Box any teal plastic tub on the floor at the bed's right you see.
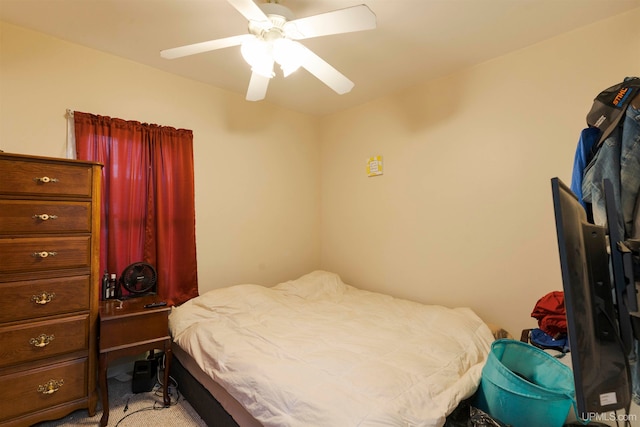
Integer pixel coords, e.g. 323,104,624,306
475,339,575,427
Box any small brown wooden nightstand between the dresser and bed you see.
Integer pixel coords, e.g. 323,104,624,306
98,295,171,426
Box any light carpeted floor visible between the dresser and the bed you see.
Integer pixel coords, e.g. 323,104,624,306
36,378,206,427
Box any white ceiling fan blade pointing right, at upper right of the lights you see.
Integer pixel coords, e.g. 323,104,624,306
284,4,376,40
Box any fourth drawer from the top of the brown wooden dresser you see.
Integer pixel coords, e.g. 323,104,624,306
0,275,91,323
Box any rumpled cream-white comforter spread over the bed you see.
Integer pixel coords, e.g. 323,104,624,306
169,271,493,427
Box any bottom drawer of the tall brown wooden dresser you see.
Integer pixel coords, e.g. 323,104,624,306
0,359,87,422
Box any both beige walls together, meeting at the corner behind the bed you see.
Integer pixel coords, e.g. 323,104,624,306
0,10,640,334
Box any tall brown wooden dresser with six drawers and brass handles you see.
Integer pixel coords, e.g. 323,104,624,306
0,153,101,426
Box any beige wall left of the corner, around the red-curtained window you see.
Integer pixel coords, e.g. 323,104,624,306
0,23,320,292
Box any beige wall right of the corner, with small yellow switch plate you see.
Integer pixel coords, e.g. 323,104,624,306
321,9,640,336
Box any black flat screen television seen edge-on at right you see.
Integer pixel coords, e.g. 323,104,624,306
551,178,635,420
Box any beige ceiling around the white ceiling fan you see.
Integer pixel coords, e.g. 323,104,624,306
0,0,640,115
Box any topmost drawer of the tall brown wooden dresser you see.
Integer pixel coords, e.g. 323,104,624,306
0,159,92,197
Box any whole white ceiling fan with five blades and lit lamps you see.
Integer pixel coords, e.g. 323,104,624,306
160,0,376,101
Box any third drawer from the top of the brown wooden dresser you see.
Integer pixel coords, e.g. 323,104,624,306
0,236,91,273
